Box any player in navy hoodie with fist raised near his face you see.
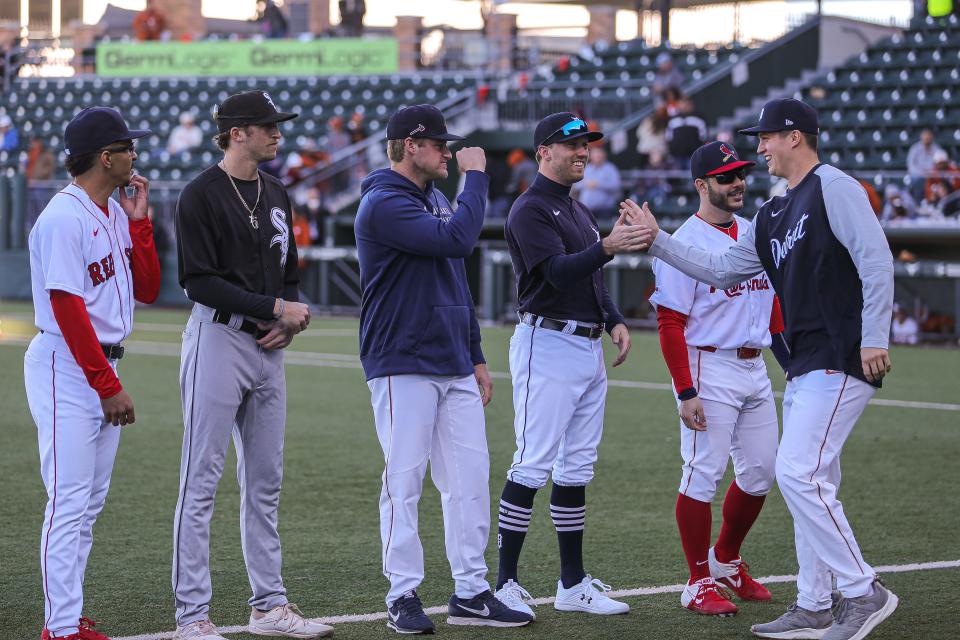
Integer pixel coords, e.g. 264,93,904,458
354,104,533,634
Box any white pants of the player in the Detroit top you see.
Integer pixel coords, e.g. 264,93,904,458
777,370,876,611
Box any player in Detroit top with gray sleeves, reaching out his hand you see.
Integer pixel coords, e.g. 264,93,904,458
621,99,898,640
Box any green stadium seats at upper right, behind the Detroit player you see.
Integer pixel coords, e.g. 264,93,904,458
624,16,960,220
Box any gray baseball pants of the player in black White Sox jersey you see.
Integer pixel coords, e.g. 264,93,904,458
173,304,287,626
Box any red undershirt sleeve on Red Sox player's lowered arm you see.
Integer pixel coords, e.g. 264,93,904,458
50,289,123,398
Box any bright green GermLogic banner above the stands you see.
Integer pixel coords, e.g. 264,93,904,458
97,38,398,78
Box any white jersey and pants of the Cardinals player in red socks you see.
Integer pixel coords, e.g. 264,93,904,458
650,216,777,502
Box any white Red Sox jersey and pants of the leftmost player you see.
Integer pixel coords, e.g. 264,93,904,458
24,185,134,636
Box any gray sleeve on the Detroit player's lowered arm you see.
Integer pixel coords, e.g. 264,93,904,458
817,165,893,349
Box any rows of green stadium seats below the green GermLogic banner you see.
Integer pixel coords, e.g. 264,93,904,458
0,73,476,180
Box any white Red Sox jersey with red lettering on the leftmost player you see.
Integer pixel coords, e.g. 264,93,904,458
29,184,133,344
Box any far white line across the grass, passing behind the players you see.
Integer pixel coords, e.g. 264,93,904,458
0,334,960,411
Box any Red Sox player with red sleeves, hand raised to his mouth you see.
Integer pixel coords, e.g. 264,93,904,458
23,107,160,640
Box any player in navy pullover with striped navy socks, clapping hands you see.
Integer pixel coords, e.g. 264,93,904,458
497,113,641,615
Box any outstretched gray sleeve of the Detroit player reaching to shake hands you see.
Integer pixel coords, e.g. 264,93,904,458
650,224,763,289
